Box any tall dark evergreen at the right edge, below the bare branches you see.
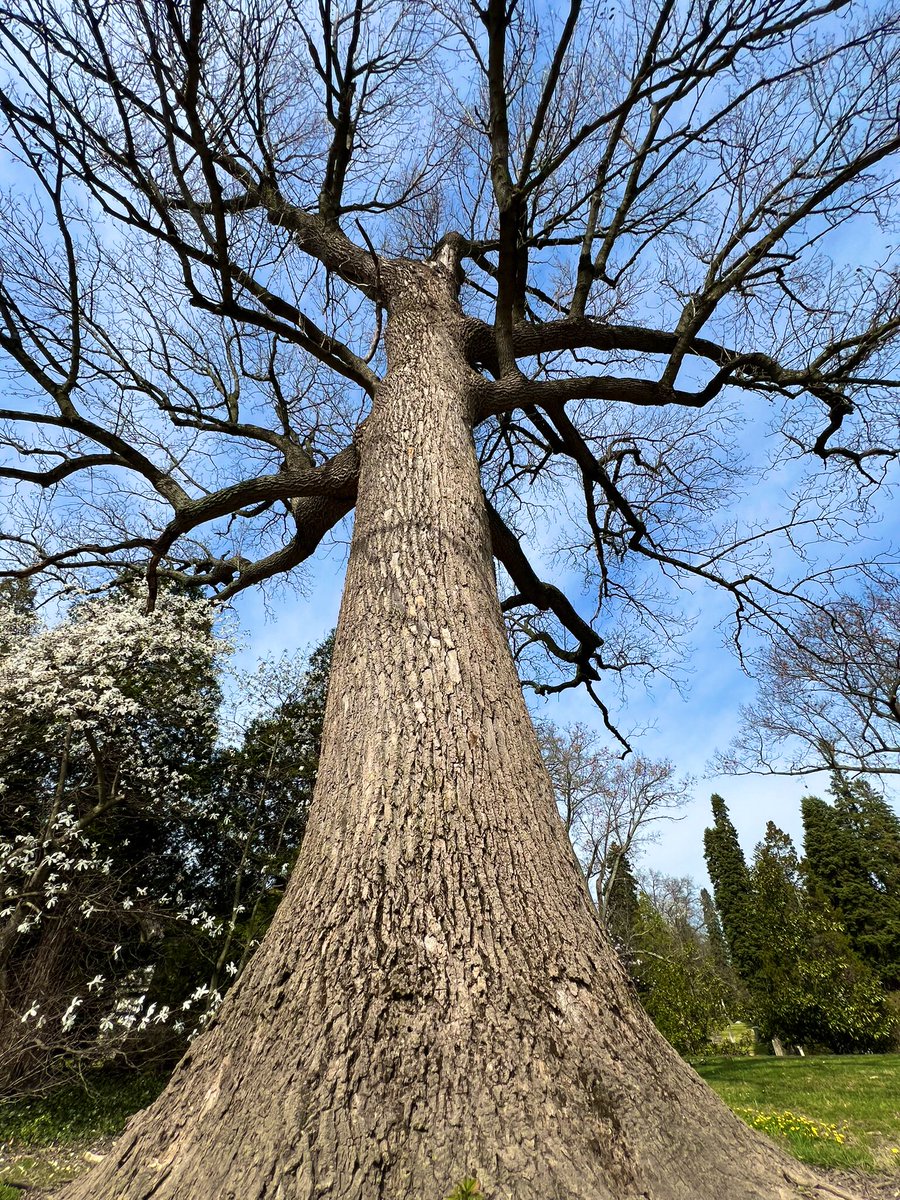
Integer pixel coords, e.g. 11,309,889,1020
802,774,900,990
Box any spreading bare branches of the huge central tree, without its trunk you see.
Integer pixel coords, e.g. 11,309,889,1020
0,0,900,729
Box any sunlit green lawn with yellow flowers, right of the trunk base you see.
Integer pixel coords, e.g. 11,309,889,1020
695,1054,900,1180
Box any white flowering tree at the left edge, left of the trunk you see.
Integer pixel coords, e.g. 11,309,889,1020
0,595,228,1090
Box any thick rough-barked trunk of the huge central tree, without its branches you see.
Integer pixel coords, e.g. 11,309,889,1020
65,264,859,1200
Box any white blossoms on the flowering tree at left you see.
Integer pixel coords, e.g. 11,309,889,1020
0,596,254,1038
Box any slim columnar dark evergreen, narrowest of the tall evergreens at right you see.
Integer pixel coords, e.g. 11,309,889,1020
703,796,760,984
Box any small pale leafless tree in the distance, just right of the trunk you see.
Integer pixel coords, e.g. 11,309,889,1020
536,721,691,918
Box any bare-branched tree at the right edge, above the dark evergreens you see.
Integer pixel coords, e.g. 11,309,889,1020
719,578,900,775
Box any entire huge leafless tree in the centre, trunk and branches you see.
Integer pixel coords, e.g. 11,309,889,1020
0,0,900,1200
